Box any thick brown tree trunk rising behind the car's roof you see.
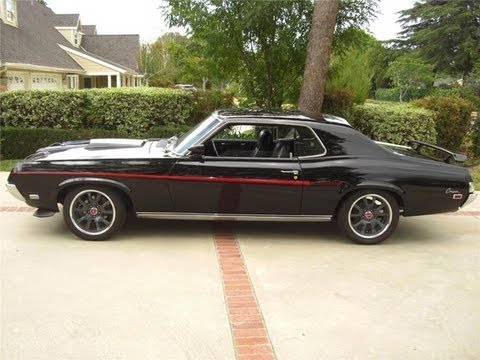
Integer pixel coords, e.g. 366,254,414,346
298,0,340,117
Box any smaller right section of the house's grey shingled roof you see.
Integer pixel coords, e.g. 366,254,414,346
82,35,140,72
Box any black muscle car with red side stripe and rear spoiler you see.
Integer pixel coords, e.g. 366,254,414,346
7,111,475,244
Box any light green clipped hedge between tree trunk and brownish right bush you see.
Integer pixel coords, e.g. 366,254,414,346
349,103,436,144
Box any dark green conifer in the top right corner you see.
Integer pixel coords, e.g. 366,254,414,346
400,0,480,80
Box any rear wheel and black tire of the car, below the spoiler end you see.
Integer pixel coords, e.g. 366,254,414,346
337,190,399,245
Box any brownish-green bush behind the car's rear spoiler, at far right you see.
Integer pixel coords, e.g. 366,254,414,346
415,96,474,151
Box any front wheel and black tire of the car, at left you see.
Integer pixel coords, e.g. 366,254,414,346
63,185,127,240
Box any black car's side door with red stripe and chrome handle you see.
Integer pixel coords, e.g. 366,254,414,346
170,123,302,215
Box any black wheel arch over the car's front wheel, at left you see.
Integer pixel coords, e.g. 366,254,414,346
57,177,134,210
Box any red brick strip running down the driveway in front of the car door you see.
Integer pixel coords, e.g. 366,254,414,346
213,224,276,360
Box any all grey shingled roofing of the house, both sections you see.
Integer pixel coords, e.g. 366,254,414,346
0,0,140,72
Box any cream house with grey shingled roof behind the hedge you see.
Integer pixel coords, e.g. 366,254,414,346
0,0,142,91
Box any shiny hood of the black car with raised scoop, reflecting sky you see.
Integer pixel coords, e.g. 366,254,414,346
25,139,172,161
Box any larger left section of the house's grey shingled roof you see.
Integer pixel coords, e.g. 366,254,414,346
0,0,83,71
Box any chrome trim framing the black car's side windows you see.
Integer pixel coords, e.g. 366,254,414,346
181,117,327,161
